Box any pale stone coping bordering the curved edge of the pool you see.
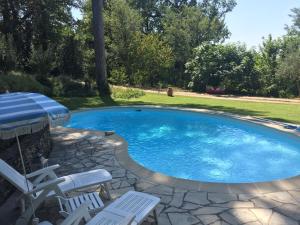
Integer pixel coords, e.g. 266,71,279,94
74,105,300,194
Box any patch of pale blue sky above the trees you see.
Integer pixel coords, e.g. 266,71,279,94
225,0,300,47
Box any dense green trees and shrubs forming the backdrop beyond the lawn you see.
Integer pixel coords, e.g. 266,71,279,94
0,0,300,97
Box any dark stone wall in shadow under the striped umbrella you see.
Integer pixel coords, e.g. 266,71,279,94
0,126,52,205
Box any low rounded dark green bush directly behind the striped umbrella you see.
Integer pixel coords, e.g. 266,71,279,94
0,72,50,94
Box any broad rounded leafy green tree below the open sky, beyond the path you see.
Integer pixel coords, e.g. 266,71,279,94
186,43,258,94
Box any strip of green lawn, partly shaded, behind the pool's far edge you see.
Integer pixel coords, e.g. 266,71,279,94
57,93,300,124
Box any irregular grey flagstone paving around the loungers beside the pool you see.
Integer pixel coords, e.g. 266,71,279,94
39,128,300,225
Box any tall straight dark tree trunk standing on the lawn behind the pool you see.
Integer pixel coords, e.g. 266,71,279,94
92,0,110,96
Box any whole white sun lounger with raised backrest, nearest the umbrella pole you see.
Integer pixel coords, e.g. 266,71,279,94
0,159,112,224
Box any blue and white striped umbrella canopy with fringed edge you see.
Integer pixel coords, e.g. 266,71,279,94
0,92,70,139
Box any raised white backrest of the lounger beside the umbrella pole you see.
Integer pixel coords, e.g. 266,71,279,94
0,159,33,193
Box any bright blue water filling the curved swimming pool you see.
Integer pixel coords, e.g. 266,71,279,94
67,107,300,183
